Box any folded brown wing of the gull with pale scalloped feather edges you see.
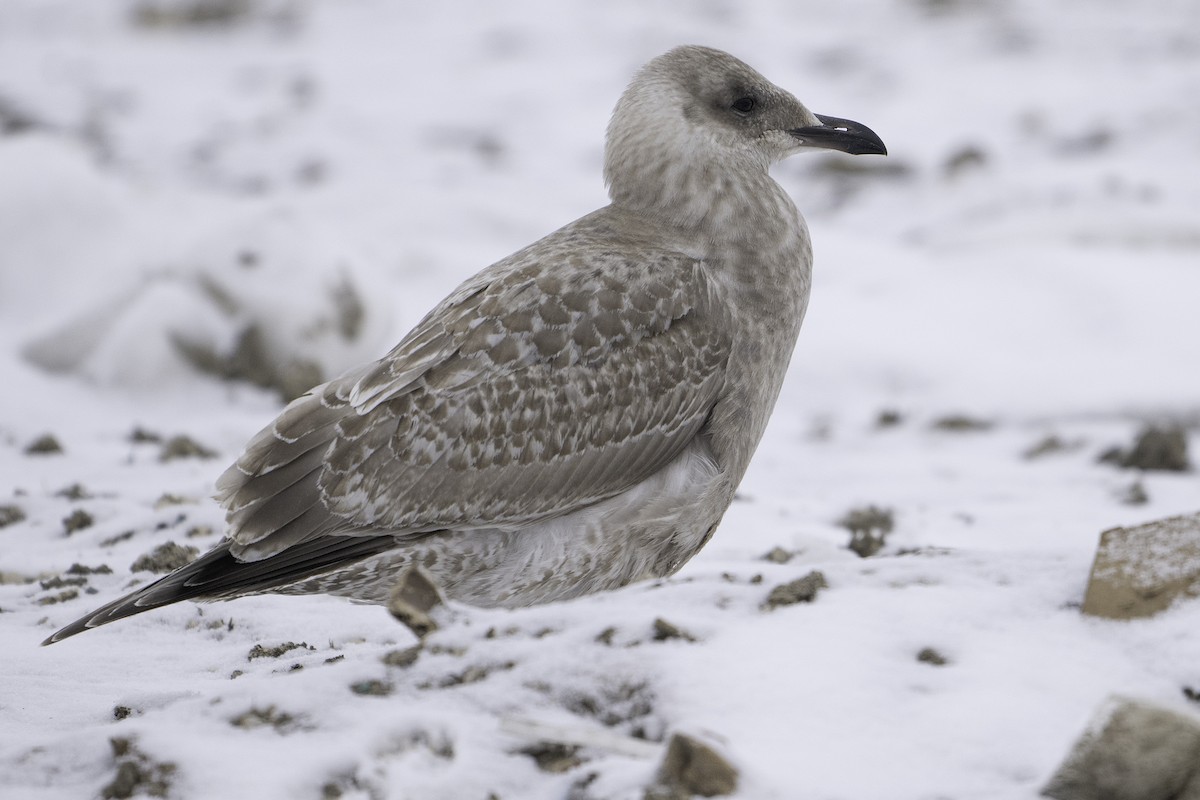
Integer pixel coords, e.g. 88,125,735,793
217,229,730,560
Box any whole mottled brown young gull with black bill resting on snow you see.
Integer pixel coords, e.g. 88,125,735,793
46,47,887,644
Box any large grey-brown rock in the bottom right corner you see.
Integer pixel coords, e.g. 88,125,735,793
1042,697,1200,800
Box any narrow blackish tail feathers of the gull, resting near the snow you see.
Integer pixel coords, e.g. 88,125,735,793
42,535,396,645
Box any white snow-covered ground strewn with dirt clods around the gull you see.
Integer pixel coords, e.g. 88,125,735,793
0,0,1200,800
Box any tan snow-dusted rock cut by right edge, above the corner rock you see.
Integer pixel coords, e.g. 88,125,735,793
1082,512,1200,619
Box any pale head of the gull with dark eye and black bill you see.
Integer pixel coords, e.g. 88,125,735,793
605,46,887,217
